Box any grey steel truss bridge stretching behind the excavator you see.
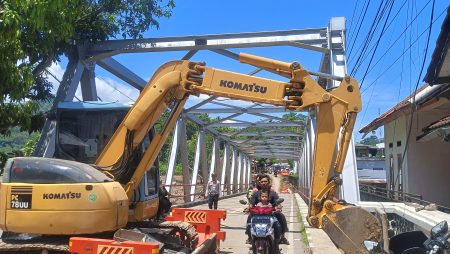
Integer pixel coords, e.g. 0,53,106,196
35,17,359,203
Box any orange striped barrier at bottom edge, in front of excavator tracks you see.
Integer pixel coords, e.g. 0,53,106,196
69,237,159,254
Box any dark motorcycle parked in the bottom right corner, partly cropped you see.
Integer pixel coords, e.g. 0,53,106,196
389,221,450,254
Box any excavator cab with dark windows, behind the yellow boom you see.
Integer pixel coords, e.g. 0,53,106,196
52,101,160,221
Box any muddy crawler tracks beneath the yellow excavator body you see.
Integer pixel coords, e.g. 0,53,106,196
0,221,198,254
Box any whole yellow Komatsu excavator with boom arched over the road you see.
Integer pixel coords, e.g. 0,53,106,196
0,53,381,253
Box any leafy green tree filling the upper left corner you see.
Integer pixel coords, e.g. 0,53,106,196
0,0,175,134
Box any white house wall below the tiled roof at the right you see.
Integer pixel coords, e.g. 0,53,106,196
384,110,450,207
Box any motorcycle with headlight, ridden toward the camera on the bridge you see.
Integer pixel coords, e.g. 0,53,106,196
239,198,284,254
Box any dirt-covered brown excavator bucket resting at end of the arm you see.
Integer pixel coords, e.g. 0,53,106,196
322,206,382,254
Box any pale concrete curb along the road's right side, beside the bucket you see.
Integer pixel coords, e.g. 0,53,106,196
294,193,341,254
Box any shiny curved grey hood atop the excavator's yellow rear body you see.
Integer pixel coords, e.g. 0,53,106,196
3,157,112,184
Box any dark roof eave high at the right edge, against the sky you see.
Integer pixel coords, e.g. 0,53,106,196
423,5,450,86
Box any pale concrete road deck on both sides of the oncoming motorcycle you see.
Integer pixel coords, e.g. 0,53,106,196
197,194,309,254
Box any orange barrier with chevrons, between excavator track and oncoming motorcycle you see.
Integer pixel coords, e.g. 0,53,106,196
166,208,227,246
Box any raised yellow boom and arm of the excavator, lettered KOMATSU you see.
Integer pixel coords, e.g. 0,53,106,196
96,54,377,252
